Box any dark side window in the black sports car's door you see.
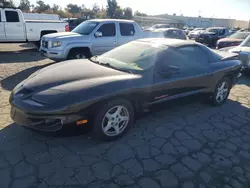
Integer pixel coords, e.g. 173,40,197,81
178,46,209,67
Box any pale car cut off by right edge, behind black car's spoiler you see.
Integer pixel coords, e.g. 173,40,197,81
220,35,250,75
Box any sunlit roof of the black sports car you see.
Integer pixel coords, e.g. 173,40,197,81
137,38,197,47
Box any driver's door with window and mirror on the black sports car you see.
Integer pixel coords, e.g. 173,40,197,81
150,45,209,103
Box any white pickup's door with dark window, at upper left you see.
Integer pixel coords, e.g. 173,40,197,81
4,10,26,41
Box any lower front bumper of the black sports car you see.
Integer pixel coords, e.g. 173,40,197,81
10,105,86,132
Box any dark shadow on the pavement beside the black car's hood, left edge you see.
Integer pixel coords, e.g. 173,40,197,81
1,62,55,91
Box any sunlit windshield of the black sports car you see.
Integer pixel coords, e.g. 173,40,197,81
94,41,166,72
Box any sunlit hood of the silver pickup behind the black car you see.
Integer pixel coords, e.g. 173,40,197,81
43,32,89,40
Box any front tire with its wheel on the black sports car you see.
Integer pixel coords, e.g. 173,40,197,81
93,99,134,141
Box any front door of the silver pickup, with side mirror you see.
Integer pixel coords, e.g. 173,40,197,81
92,22,117,55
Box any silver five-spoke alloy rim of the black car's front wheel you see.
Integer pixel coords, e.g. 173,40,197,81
102,105,130,136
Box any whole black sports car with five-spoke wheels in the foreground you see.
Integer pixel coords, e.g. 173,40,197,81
10,38,241,140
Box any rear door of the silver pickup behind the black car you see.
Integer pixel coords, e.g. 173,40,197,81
118,22,137,46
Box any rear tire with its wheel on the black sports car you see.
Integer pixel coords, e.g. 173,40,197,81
211,77,232,106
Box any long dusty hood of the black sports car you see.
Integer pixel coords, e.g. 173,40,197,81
13,60,141,104
